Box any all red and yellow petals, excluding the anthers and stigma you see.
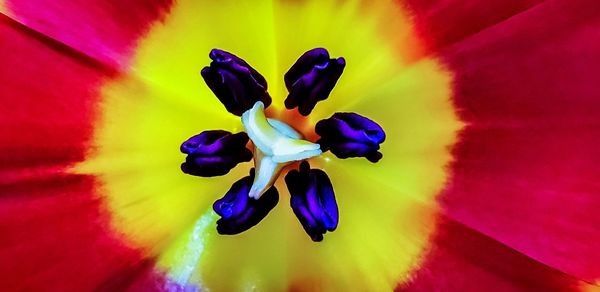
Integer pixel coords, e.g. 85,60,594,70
0,0,600,291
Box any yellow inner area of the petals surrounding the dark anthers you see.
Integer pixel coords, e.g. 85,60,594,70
74,0,461,291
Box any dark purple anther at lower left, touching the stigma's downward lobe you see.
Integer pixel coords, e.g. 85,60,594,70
213,169,279,234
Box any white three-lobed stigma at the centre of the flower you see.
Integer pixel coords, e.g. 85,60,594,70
242,101,322,199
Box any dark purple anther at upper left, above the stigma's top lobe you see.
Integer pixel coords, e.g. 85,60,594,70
201,49,271,116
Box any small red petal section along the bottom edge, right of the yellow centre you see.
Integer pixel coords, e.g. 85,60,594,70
397,219,581,291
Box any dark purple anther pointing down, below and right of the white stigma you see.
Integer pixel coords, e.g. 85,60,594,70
285,161,339,241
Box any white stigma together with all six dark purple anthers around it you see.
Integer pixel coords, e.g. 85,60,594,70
181,48,385,241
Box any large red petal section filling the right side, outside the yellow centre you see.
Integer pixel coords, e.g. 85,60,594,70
434,0,600,281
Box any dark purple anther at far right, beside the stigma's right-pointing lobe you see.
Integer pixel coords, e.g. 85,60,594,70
315,113,385,162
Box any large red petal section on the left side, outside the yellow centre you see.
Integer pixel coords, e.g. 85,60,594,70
0,16,162,291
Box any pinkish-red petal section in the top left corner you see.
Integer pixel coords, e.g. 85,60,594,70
3,0,172,67
